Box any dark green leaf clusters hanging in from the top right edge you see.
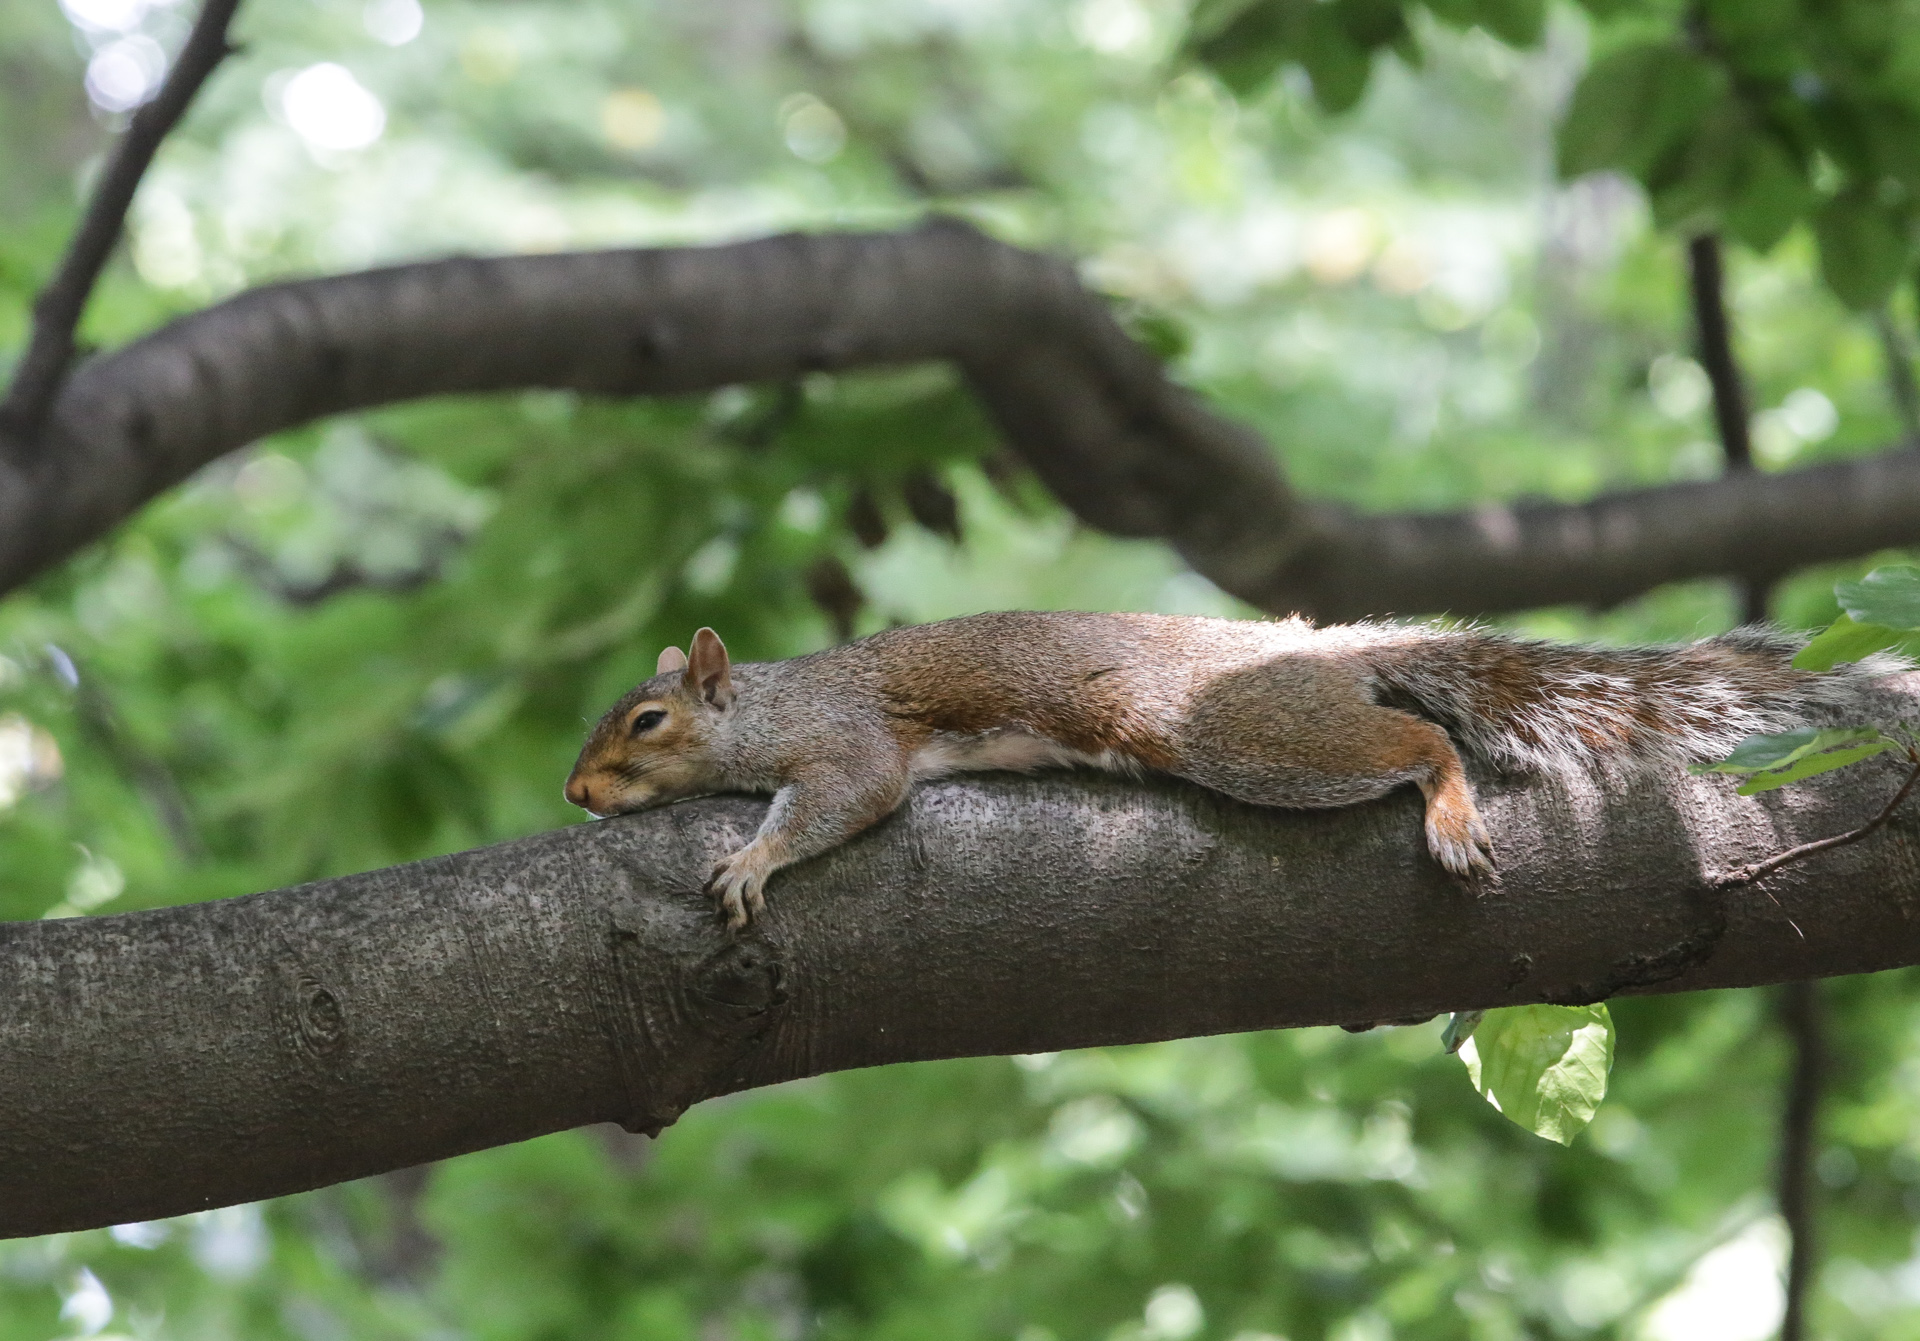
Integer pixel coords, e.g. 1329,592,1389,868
1190,0,1920,309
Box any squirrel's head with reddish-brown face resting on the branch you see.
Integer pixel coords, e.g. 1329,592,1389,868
566,628,733,817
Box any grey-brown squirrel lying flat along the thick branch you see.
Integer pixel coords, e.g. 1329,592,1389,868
566,613,1901,930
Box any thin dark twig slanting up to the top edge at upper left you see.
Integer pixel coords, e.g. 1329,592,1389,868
0,0,240,459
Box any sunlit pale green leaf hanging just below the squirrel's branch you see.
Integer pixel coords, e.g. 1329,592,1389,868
1459,1003,1613,1145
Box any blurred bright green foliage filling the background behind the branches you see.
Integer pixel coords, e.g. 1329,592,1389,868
0,0,1920,1341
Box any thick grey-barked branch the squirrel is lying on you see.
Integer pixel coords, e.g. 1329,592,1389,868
11,680,1920,1235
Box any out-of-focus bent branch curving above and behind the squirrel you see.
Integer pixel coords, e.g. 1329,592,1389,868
11,223,1920,619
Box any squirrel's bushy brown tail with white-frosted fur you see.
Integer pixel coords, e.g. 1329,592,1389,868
1361,626,1908,772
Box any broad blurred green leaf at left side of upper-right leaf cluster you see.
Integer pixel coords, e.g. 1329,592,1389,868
1559,42,1726,181
